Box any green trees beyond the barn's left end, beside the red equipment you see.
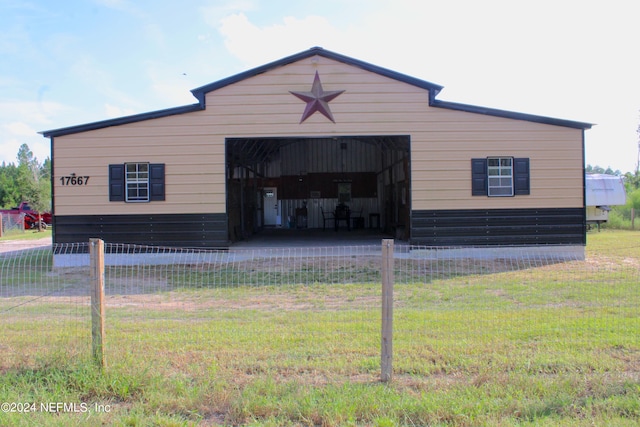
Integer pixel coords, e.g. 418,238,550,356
0,144,51,212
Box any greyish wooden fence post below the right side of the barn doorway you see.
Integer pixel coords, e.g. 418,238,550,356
380,239,394,382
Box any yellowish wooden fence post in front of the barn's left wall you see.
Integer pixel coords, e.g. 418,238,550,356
89,239,106,368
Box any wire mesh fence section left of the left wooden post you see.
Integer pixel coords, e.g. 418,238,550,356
0,244,91,370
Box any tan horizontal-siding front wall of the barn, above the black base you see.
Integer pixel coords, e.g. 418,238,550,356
53,56,583,215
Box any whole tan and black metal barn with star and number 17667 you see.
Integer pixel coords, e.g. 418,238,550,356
42,48,591,248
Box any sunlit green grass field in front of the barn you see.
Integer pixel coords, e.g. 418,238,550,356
0,231,640,427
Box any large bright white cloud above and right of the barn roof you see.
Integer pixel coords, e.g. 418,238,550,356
211,0,640,170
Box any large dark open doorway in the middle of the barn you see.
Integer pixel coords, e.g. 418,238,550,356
226,136,411,243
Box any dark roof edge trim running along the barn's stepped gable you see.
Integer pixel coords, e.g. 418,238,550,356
40,47,592,137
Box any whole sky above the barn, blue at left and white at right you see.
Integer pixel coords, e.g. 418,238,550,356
0,0,640,172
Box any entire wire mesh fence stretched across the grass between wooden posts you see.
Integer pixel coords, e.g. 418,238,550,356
0,239,640,382
